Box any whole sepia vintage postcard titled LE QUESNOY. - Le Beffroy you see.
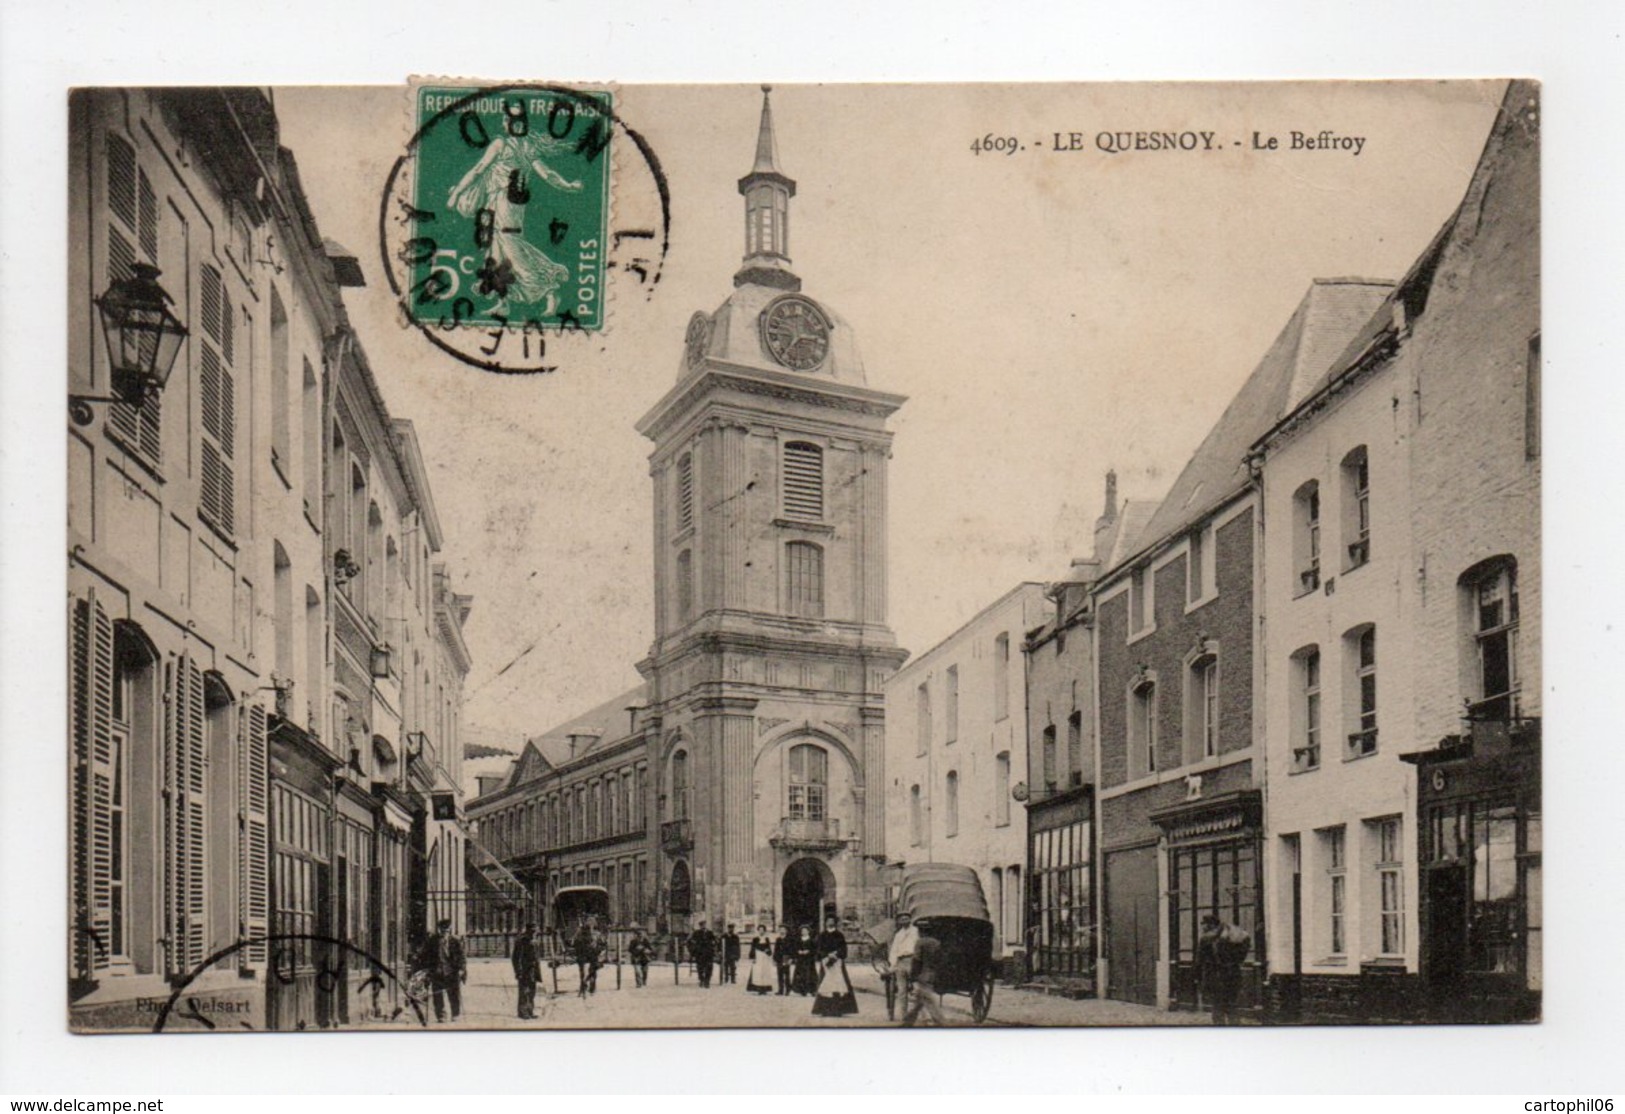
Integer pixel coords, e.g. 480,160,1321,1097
62,75,1544,1033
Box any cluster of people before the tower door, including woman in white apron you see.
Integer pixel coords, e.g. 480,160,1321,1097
687,918,858,1017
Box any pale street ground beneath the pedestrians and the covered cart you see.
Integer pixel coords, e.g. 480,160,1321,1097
358,960,1209,1030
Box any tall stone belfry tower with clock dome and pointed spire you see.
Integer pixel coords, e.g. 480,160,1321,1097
637,86,907,926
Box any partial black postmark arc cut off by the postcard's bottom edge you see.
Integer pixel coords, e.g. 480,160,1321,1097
153,932,429,1033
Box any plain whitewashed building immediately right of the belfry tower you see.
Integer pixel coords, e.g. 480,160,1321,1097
884,581,1045,956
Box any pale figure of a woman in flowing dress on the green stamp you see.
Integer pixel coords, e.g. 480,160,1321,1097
445,132,582,317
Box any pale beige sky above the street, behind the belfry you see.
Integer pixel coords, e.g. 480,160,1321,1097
275,81,1502,750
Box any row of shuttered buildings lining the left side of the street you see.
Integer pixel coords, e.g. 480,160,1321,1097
68,89,468,1028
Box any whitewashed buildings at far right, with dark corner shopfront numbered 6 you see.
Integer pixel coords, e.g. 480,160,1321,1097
1258,83,1541,1020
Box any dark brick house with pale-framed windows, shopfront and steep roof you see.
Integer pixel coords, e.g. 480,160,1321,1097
1095,279,1386,1008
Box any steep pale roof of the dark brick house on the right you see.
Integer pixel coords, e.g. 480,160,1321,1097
1137,278,1394,552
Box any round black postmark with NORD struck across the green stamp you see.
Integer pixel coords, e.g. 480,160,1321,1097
379,84,671,373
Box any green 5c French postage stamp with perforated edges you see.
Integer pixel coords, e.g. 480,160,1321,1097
401,86,613,333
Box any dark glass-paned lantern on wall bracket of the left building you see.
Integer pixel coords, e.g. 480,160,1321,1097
68,263,187,425
